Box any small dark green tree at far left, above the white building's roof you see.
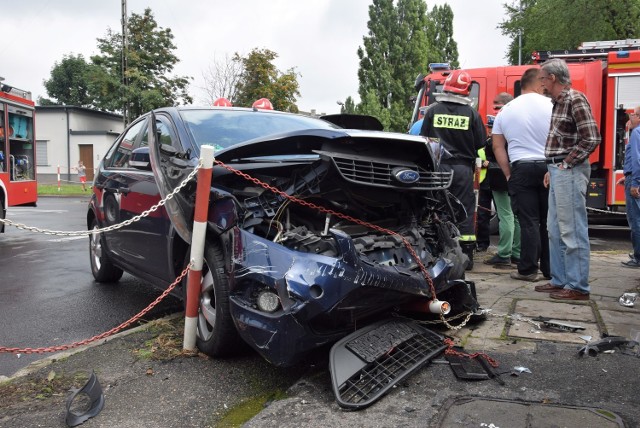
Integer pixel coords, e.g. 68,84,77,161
38,54,93,107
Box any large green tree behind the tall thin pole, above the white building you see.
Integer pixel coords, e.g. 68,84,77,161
89,8,193,119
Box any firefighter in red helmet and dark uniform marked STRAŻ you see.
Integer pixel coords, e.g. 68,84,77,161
420,70,486,270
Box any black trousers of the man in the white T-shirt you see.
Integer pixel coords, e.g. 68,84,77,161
509,161,551,277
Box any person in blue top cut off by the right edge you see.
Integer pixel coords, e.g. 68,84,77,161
618,106,640,268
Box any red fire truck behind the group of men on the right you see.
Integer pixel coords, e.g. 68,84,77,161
411,39,640,214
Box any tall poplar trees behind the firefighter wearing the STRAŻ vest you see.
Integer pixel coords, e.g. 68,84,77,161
358,0,457,132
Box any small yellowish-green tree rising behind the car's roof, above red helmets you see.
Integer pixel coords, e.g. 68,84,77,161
231,48,300,113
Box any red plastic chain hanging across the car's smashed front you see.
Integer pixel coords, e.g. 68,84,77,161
214,160,436,300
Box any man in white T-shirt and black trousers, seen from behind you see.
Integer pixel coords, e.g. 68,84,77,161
493,68,552,281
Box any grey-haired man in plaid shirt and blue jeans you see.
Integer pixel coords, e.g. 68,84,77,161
535,59,600,300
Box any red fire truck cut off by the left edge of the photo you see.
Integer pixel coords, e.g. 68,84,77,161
0,78,38,232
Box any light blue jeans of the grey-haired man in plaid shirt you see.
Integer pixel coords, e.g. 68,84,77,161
547,161,591,293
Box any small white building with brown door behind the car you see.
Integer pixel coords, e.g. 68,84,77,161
34,105,124,183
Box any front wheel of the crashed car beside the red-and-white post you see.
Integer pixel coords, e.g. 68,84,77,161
190,242,242,357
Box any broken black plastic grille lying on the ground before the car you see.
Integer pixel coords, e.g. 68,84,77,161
330,320,446,409
